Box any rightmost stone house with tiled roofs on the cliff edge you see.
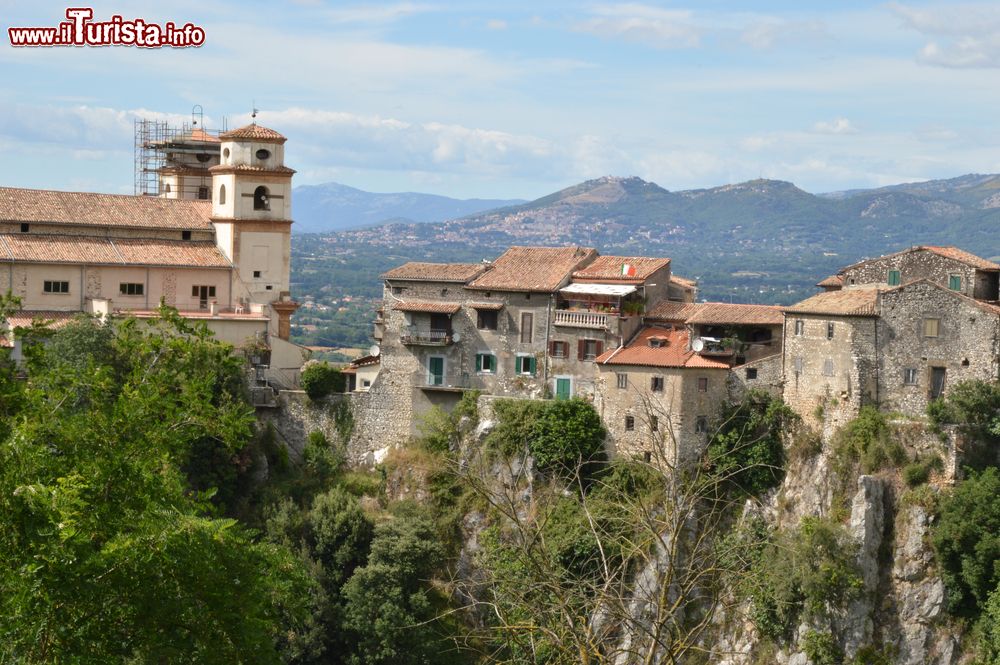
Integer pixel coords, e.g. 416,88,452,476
784,246,1000,435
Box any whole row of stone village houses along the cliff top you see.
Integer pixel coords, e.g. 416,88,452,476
347,241,1000,459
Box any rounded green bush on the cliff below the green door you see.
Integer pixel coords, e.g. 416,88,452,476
528,398,607,477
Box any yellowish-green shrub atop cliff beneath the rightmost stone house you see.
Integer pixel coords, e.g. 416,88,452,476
833,406,906,476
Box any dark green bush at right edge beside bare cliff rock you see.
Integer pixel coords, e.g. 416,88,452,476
931,467,1000,616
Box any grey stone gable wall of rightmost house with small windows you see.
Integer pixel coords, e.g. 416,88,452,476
878,282,1000,417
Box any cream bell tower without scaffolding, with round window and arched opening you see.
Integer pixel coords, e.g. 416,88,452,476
209,123,298,340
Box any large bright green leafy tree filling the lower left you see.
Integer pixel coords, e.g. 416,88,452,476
0,309,309,663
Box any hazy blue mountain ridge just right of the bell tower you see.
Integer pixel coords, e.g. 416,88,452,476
293,182,522,233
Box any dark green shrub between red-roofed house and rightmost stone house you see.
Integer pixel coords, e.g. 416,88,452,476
708,390,798,496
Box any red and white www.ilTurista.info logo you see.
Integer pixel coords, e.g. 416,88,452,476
7,7,205,48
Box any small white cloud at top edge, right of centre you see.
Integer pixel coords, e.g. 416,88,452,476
573,2,702,48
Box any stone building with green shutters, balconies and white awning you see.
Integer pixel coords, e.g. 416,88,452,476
357,247,672,452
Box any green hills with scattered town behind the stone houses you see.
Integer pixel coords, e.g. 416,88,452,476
309,175,1000,303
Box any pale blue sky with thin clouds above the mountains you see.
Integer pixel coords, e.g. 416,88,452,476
0,0,1000,199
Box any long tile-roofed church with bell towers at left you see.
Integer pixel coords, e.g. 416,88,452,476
0,124,303,385
